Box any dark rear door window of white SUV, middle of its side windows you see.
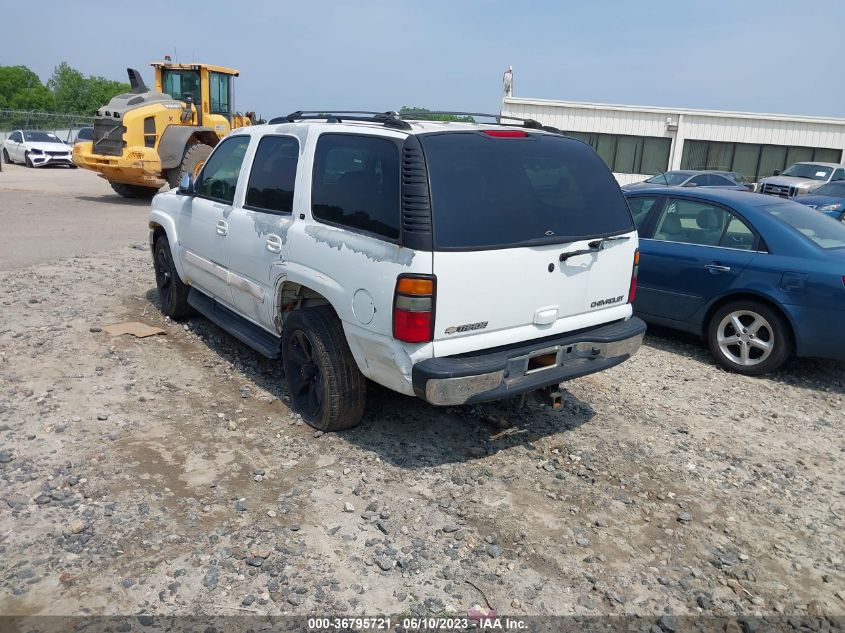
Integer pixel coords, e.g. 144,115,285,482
245,136,299,213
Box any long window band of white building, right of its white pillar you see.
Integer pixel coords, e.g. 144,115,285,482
681,140,842,181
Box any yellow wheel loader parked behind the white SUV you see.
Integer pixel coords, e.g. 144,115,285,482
73,62,255,198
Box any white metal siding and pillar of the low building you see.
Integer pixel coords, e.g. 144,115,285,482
501,97,845,184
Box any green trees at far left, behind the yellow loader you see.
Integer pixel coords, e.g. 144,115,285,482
0,62,129,116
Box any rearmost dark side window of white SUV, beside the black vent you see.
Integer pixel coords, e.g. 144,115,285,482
311,134,400,240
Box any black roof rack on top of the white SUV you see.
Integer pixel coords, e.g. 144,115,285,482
269,110,563,134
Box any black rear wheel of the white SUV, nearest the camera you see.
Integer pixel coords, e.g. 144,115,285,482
282,306,366,431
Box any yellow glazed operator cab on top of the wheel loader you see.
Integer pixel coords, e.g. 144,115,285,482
152,62,240,138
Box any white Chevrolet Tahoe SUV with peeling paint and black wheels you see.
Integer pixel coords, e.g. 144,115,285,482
150,112,645,430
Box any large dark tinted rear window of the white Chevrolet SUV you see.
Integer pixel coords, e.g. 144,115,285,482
420,132,634,250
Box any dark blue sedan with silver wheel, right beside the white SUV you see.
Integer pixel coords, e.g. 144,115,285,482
626,187,845,375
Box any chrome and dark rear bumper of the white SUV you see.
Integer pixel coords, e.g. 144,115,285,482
412,317,646,405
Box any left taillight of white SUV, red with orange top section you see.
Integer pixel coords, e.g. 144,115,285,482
393,275,436,343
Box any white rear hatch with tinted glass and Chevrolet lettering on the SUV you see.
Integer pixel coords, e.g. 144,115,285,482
420,129,637,356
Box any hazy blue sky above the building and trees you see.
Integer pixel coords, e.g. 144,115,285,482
0,0,845,118
